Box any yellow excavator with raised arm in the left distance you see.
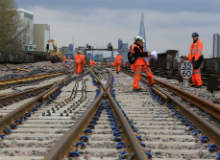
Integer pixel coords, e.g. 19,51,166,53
48,39,63,63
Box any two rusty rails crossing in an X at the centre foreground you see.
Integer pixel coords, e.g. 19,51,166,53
44,71,147,160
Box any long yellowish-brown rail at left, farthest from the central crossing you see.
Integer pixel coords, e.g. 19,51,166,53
0,72,65,87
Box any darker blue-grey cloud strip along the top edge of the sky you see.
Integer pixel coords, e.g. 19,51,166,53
17,0,220,13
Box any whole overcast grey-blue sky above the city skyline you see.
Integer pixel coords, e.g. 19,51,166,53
16,0,220,57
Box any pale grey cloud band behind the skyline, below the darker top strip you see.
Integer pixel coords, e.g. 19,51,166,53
30,7,220,57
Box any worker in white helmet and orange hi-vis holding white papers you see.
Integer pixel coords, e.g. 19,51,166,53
128,36,157,91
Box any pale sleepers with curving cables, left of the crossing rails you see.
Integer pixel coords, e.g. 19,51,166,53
0,73,95,160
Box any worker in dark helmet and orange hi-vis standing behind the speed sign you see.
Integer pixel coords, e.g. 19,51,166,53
187,32,203,88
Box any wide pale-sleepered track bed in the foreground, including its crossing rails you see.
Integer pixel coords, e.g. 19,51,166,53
0,68,220,160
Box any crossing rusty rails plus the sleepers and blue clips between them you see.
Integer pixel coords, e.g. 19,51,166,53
45,69,148,160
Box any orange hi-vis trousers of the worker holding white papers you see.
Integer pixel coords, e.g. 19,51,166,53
133,65,155,89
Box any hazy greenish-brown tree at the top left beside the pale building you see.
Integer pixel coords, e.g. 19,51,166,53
0,0,27,53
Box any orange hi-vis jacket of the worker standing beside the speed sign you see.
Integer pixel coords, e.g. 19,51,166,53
188,39,203,62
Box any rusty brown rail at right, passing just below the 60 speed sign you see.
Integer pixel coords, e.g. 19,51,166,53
155,78,220,120
